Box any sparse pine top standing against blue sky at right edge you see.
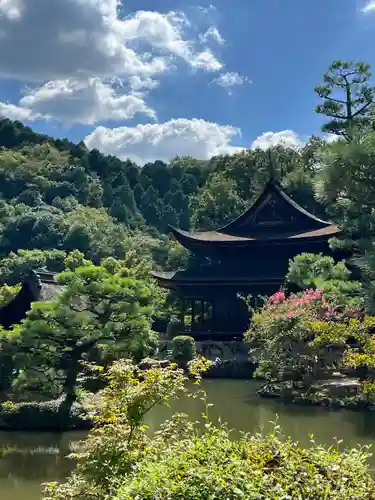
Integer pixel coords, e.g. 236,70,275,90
315,60,375,141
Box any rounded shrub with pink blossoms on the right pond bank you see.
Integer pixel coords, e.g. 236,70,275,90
246,288,347,385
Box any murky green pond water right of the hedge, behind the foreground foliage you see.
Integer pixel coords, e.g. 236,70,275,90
148,380,375,452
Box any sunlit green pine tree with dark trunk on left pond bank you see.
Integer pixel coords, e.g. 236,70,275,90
16,259,157,414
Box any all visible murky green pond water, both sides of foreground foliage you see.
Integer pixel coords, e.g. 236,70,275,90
0,380,375,500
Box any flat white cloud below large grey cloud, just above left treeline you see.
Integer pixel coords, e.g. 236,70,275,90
6,78,156,125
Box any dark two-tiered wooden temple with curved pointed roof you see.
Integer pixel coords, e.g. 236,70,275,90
153,181,340,340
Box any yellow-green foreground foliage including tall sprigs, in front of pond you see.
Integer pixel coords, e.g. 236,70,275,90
44,363,375,500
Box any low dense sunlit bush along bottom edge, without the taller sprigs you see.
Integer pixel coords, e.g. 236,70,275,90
113,426,375,500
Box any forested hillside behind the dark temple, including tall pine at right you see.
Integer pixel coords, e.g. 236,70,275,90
0,61,375,279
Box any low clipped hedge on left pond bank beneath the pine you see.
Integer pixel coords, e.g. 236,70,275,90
0,399,91,431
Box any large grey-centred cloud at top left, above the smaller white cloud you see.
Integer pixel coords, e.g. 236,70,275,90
0,0,221,83
